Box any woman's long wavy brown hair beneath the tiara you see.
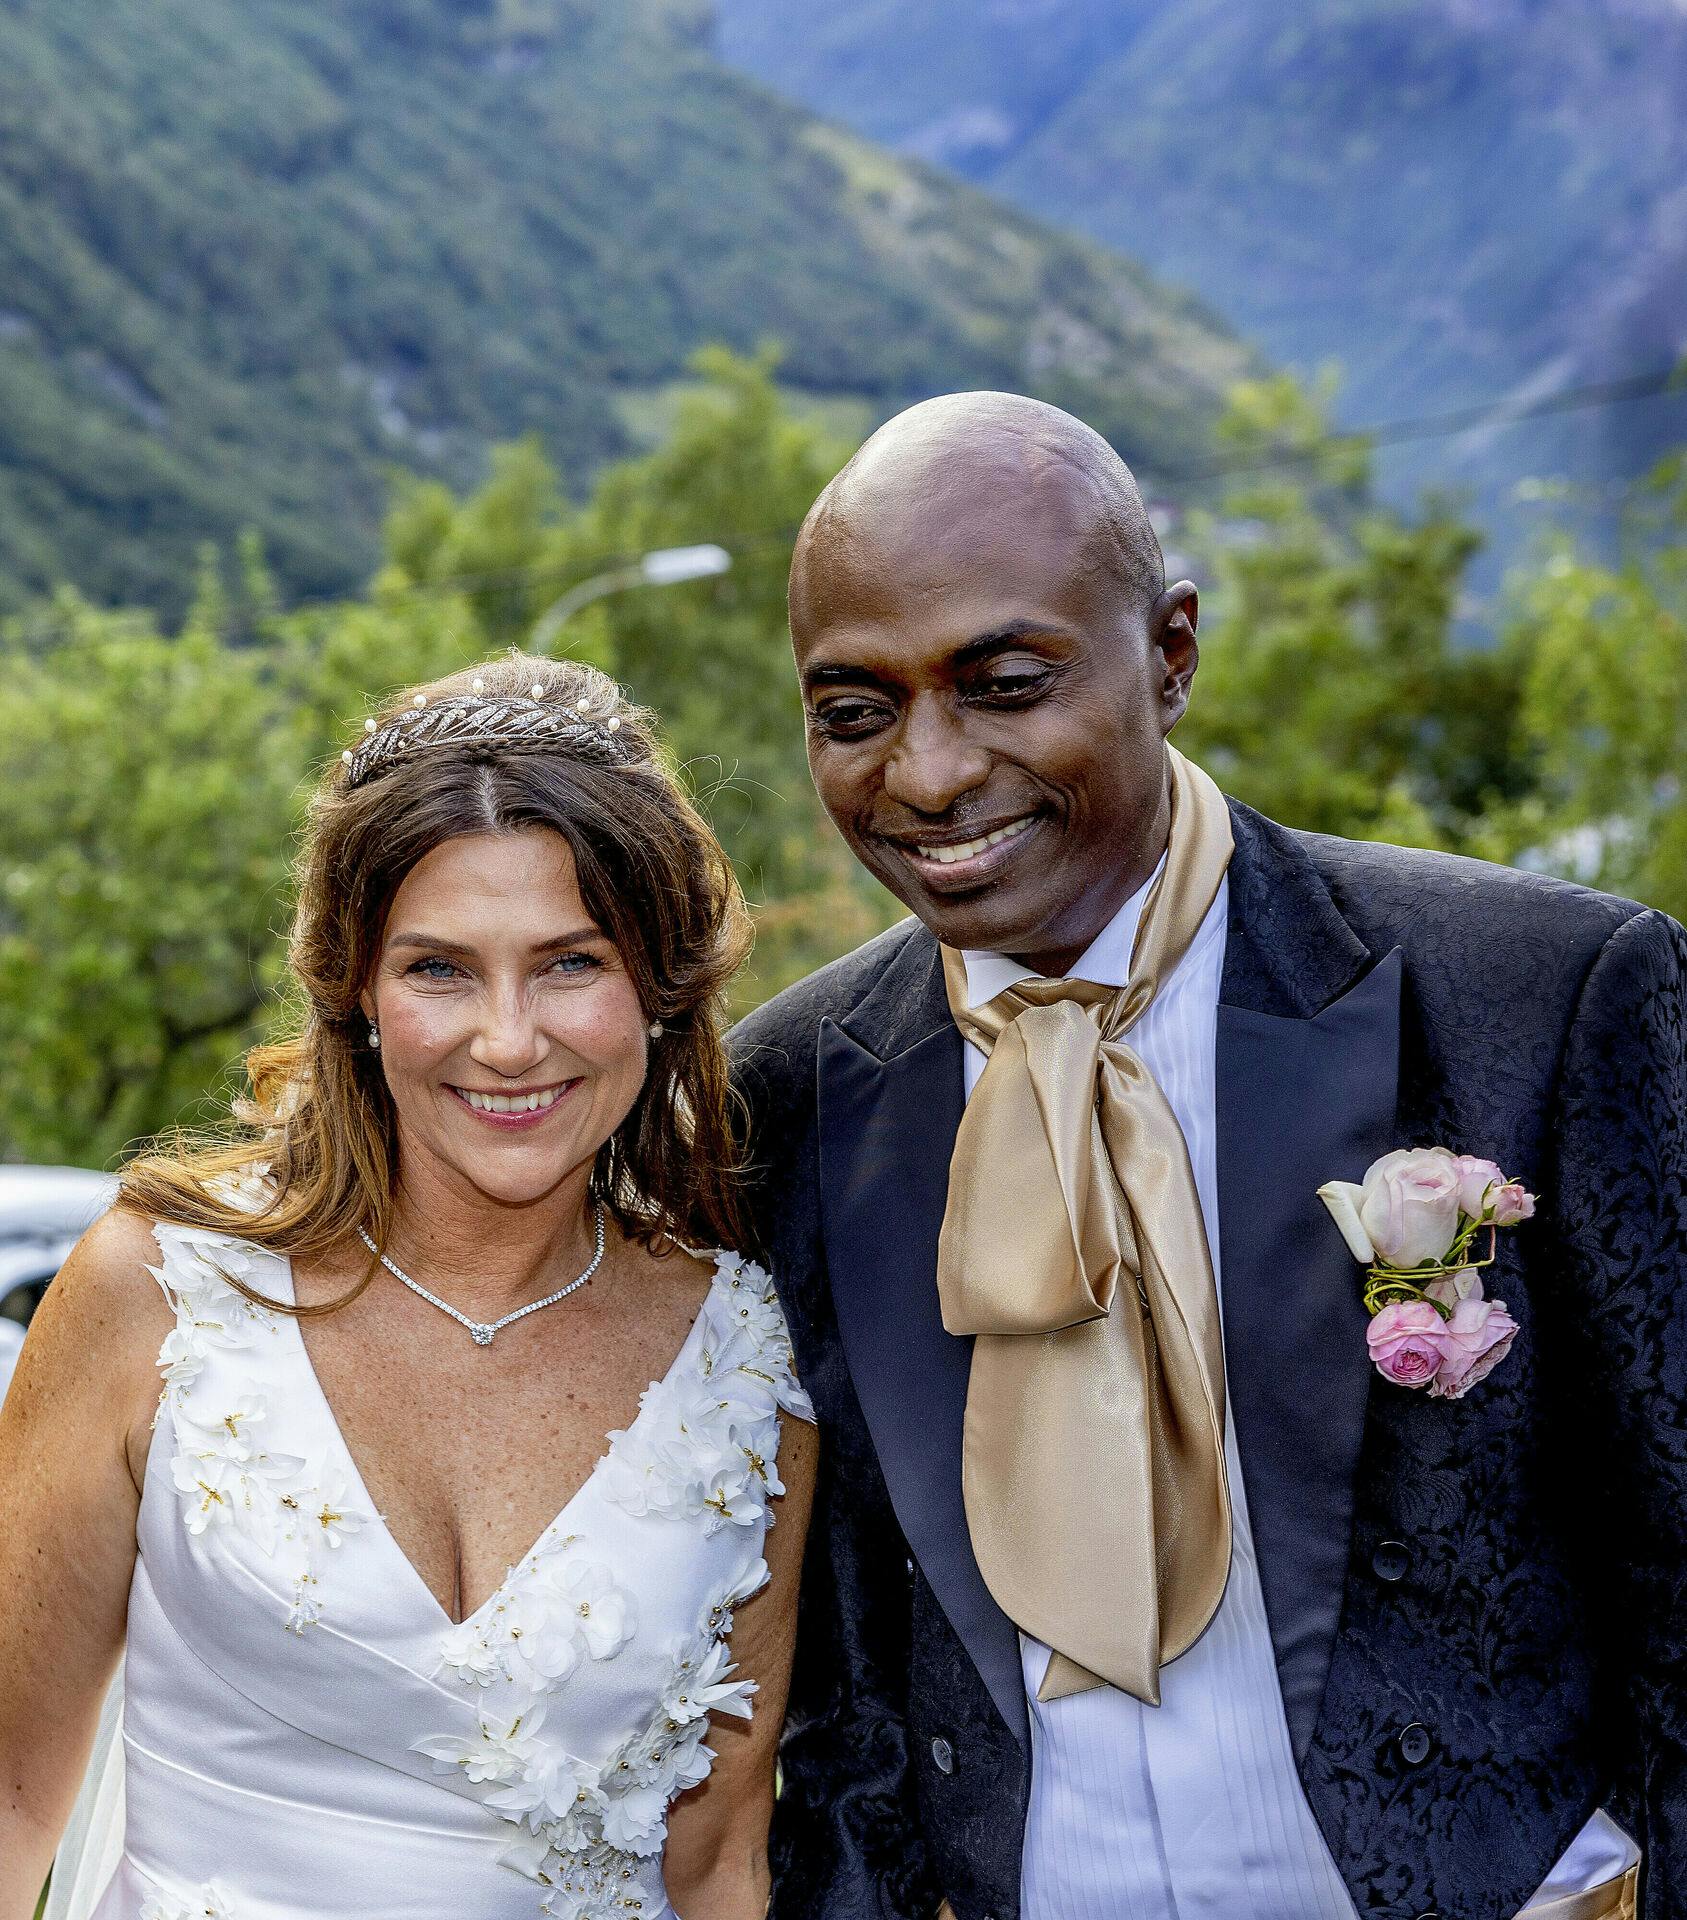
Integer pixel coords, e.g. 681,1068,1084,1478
121,651,750,1313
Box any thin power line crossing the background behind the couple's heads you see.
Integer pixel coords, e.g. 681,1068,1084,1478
19,361,1687,655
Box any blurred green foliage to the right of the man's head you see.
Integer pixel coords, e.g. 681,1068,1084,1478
1178,376,1687,916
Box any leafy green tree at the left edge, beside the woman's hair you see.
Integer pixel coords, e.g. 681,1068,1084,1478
0,595,299,1162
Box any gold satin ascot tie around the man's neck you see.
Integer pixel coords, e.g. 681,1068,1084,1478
937,749,1232,1707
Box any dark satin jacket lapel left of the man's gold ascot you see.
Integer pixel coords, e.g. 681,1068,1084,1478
818,931,1031,1745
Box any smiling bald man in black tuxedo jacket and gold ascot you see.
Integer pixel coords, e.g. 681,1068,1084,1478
735,394,1687,1920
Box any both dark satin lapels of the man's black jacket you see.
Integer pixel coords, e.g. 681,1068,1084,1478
818,803,1401,1759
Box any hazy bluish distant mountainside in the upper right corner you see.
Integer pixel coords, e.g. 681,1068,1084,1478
716,0,1687,560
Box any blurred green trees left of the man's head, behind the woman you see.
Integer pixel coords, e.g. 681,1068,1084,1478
0,351,894,1164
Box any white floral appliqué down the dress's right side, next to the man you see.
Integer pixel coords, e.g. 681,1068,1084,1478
416,1256,814,1920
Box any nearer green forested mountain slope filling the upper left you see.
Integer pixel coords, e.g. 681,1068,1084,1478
0,0,1251,609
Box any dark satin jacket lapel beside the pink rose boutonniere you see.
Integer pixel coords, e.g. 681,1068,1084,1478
1217,803,1401,1763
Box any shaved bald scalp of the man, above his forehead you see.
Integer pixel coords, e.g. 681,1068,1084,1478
791,394,1165,632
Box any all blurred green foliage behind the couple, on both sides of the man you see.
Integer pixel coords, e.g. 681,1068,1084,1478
0,349,1687,1164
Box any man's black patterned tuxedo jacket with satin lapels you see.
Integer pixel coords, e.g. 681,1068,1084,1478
733,803,1687,1920
